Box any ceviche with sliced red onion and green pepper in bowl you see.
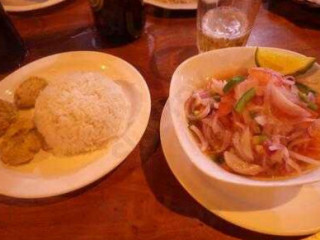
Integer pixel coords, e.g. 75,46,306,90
185,67,320,178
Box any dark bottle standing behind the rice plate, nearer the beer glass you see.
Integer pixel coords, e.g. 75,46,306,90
90,0,145,44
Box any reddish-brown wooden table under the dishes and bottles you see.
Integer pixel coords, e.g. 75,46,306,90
0,0,320,240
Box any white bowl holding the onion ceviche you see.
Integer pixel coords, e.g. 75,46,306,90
169,47,320,187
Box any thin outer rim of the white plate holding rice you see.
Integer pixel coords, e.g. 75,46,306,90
0,51,151,199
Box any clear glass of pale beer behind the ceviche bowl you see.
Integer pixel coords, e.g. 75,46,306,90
197,0,261,52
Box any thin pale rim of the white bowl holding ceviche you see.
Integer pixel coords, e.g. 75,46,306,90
169,46,320,187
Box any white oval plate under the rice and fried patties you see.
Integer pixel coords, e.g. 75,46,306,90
0,51,151,198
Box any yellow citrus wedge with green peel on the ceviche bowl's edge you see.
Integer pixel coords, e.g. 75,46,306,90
255,48,316,75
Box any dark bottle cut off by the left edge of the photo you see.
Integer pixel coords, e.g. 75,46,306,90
0,3,27,73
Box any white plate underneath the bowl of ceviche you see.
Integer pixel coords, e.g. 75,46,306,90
160,103,320,235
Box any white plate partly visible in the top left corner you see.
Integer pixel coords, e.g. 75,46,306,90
1,0,66,12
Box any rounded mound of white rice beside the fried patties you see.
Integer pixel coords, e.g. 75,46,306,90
34,72,130,155
